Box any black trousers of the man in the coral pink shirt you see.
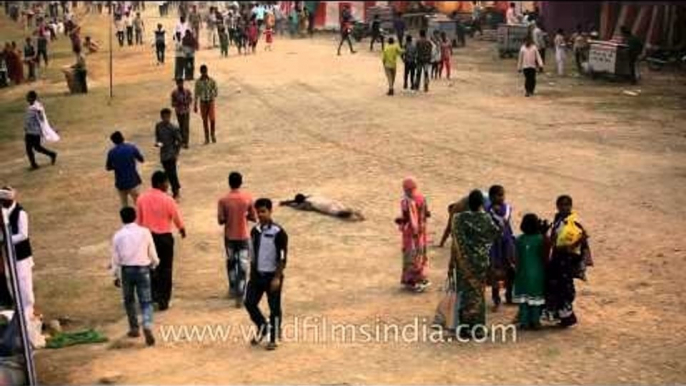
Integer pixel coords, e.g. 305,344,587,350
150,233,174,309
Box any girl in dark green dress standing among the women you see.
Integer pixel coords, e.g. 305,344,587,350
513,213,550,329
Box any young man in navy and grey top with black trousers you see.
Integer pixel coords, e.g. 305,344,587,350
245,198,288,350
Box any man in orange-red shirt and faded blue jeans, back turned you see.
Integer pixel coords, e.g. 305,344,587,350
217,172,257,307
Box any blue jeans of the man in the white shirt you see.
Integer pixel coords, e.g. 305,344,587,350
121,266,152,330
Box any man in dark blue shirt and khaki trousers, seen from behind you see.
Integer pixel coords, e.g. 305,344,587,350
106,131,145,207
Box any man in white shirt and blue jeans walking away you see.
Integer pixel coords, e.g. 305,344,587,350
111,207,160,346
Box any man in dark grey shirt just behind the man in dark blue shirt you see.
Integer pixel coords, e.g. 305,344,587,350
155,108,183,199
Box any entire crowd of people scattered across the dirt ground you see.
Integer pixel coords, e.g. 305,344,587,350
0,2,608,350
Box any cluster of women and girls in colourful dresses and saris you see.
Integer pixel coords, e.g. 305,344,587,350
430,185,593,333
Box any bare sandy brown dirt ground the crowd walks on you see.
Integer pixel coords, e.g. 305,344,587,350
0,6,686,384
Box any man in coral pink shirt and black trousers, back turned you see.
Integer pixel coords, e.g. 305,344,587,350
136,171,186,311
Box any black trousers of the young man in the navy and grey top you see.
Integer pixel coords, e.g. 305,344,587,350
245,272,283,342
